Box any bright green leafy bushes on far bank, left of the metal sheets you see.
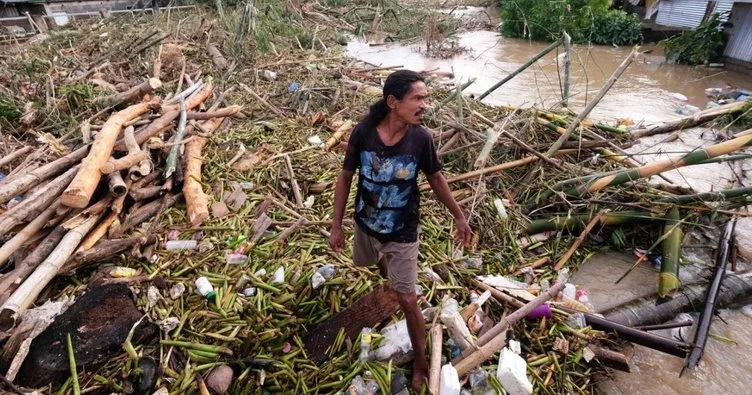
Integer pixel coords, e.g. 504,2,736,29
500,0,642,45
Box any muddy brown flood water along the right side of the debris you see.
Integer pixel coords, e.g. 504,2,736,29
347,26,752,395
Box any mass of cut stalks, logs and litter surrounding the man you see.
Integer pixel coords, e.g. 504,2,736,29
0,4,752,394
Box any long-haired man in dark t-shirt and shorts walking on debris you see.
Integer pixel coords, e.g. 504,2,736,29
329,70,471,391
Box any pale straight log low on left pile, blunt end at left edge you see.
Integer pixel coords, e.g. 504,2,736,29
0,215,100,331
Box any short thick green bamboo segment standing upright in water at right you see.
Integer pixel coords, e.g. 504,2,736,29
658,206,682,298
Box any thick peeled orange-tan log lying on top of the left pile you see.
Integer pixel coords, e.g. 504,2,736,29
63,99,159,208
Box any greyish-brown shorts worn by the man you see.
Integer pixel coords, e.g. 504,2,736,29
353,225,418,293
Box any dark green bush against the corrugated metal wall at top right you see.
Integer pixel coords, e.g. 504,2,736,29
660,14,726,65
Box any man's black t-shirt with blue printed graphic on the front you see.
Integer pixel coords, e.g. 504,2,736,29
343,123,442,243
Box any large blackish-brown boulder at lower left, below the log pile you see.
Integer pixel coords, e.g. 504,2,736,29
17,284,158,388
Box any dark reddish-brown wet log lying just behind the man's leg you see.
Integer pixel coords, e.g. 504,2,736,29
303,283,399,364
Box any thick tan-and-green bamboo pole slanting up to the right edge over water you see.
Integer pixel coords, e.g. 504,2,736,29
578,129,752,194
